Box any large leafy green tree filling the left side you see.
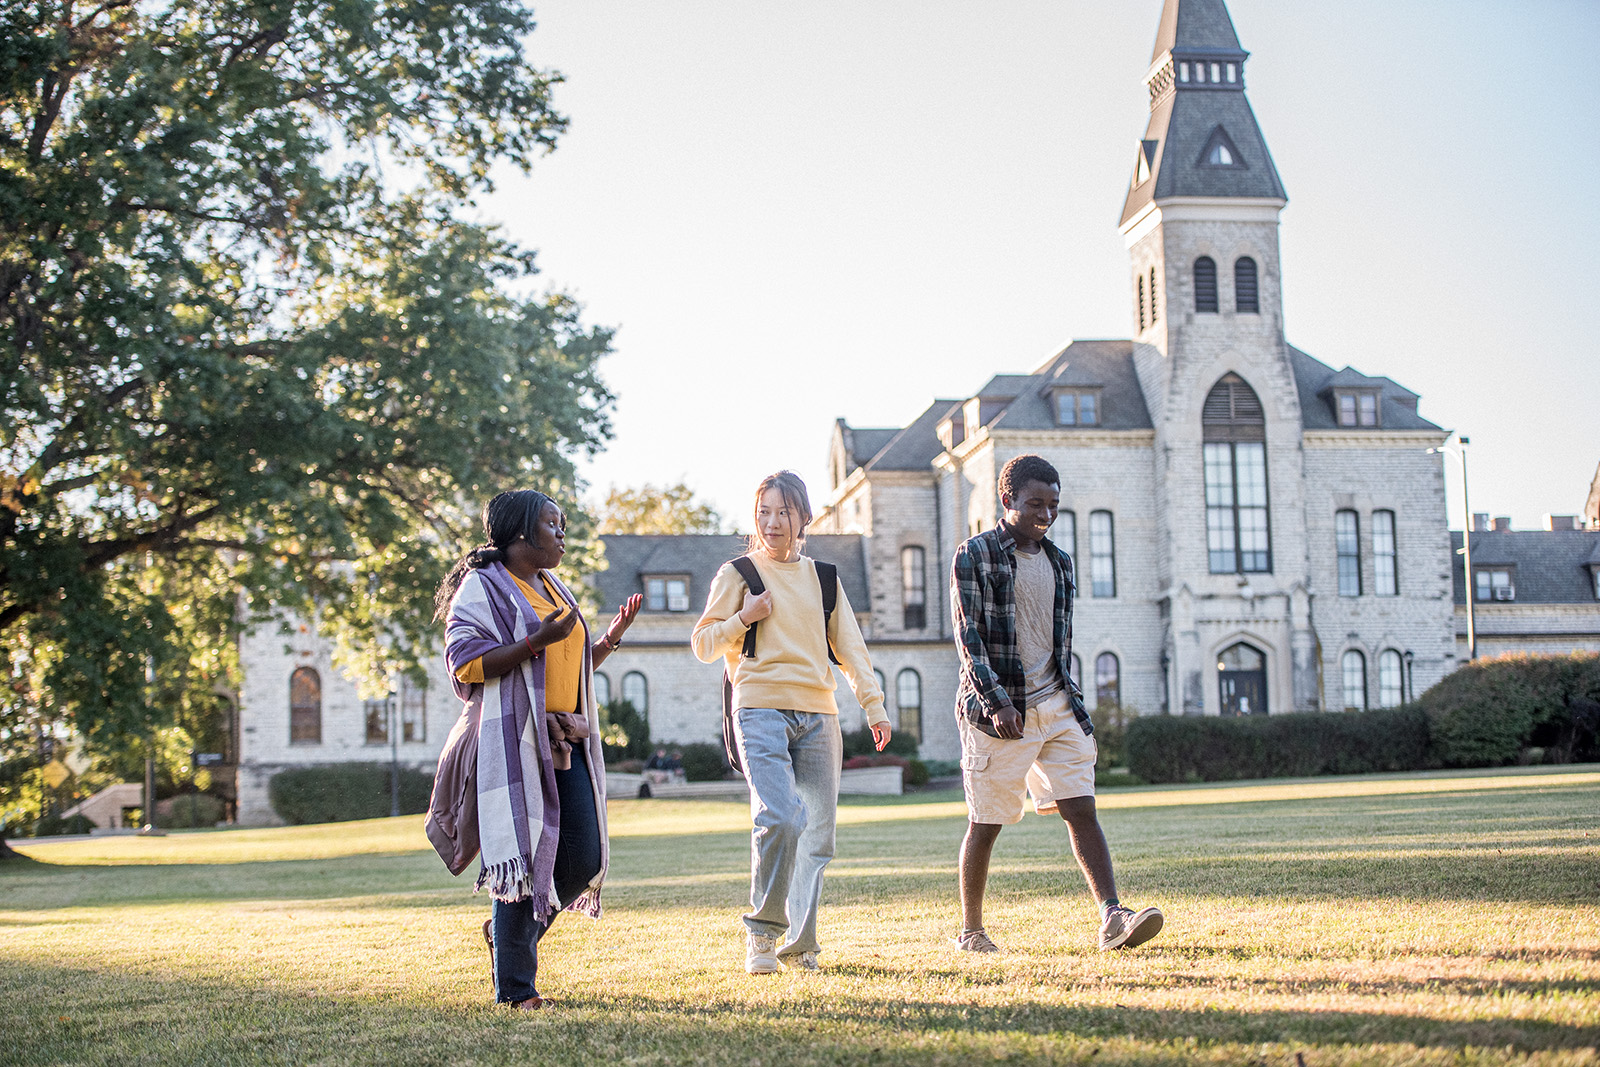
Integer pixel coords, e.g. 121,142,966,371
0,0,611,838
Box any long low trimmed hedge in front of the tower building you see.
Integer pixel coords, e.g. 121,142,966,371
1126,707,1435,782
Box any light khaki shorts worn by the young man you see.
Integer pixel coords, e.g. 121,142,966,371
957,689,1099,825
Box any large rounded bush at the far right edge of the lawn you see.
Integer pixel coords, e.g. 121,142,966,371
1418,653,1600,766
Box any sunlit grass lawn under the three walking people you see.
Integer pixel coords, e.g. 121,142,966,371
0,766,1600,1067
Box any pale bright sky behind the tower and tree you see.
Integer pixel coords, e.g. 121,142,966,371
482,0,1600,530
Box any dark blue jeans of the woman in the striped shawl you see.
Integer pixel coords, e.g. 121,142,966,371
491,744,600,1005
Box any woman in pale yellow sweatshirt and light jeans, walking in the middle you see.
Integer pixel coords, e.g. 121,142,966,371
691,470,890,974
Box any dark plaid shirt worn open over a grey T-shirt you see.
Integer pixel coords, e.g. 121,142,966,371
950,526,1094,736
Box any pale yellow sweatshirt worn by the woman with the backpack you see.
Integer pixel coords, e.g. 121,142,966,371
690,552,890,725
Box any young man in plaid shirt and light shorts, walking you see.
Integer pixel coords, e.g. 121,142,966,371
950,456,1163,952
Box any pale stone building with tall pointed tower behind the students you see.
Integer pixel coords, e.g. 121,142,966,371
228,0,1459,825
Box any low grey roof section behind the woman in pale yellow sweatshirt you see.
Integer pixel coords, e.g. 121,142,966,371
590,534,870,617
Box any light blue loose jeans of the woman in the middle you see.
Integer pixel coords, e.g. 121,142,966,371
733,707,845,957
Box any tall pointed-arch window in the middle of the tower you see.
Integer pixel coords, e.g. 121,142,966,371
1200,373,1272,574
